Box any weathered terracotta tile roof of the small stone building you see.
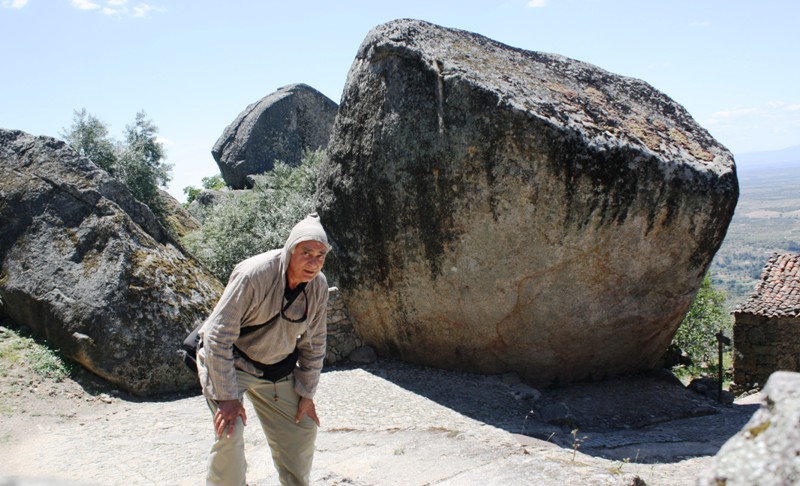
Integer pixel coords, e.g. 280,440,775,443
735,253,800,317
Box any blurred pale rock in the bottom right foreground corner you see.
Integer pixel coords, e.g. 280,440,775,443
697,371,800,486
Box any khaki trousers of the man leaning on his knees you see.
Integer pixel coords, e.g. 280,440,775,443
206,364,317,486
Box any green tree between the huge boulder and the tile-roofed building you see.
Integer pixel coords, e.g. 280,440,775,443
673,274,732,362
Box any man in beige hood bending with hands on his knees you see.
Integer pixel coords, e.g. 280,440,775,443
197,214,330,486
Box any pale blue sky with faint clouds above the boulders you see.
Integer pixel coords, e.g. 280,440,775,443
0,0,800,201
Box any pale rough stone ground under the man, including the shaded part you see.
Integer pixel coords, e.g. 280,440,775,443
0,361,757,486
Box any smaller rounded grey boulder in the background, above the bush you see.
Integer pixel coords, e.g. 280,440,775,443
211,84,338,189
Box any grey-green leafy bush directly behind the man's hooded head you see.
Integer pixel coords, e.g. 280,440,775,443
183,150,324,282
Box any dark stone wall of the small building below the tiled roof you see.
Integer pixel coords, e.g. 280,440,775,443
733,314,800,392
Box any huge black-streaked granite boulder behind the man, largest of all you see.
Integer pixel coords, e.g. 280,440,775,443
317,20,738,385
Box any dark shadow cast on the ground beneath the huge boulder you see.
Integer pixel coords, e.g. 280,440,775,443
326,360,758,464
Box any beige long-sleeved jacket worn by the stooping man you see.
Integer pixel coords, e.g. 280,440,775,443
198,249,328,400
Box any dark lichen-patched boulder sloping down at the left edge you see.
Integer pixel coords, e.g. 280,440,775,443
0,130,222,395
